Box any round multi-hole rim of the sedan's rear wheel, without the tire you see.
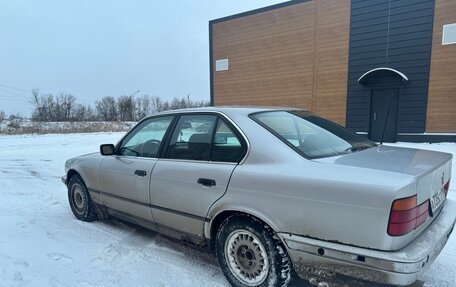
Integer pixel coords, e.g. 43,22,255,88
225,230,269,286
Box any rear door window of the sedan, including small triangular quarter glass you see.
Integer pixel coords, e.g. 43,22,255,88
165,115,246,162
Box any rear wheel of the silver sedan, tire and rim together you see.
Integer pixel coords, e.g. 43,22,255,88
215,216,293,287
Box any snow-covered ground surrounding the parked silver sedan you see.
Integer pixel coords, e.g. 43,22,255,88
0,133,456,287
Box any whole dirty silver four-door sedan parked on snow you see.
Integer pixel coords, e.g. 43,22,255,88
63,107,456,286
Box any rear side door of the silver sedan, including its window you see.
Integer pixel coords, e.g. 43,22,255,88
150,114,247,237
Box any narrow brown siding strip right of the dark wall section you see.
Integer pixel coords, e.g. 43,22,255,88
426,0,456,132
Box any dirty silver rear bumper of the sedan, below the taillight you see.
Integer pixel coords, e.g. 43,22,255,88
278,200,456,285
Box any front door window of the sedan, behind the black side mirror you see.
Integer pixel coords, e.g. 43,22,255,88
118,116,174,158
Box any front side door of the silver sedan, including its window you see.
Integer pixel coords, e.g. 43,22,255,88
100,116,174,221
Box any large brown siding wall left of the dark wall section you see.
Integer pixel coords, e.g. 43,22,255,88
212,0,350,124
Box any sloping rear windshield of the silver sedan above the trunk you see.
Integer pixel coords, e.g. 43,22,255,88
251,111,376,159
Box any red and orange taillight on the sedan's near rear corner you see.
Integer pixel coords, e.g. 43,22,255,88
388,195,429,236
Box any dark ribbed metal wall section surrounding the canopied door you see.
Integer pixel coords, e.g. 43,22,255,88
346,0,435,133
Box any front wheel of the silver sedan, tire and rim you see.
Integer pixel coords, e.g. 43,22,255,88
68,175,98,222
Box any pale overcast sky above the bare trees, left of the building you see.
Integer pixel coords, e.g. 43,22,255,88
0,0,285,116
